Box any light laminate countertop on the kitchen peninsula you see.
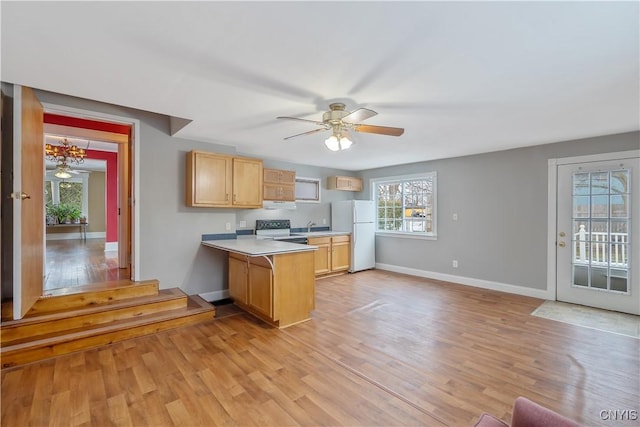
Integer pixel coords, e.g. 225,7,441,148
201,236,318,256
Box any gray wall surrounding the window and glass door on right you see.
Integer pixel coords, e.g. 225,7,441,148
361,132,640,289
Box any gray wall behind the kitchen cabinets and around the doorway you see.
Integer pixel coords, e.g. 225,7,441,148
31,90,351,300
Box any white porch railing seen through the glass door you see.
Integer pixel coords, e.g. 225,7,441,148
575,225,628,268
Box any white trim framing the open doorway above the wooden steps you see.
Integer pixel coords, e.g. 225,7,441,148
42,102,142,281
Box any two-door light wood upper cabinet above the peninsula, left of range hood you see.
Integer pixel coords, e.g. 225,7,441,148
186,151,262,208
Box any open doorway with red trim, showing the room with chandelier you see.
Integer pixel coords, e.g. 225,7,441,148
43,111,132,295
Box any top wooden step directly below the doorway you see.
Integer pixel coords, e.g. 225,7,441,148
25,280,159,317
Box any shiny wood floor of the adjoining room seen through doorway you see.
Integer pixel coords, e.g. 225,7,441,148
43,239,129,293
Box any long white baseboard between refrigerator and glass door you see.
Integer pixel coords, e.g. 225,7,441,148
376,263,555,300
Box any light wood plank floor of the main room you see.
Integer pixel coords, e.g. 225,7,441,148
1,271,640,426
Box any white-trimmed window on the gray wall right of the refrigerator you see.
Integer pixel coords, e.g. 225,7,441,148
372,172,436,237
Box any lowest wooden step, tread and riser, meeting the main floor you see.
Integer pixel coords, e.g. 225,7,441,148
0,295,215,368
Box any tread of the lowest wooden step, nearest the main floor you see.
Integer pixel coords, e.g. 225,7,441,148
0,296,215,354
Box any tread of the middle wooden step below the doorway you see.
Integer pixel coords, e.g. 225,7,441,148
0,288,187,329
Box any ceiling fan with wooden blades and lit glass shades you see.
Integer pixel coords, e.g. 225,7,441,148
276,102,404,151
